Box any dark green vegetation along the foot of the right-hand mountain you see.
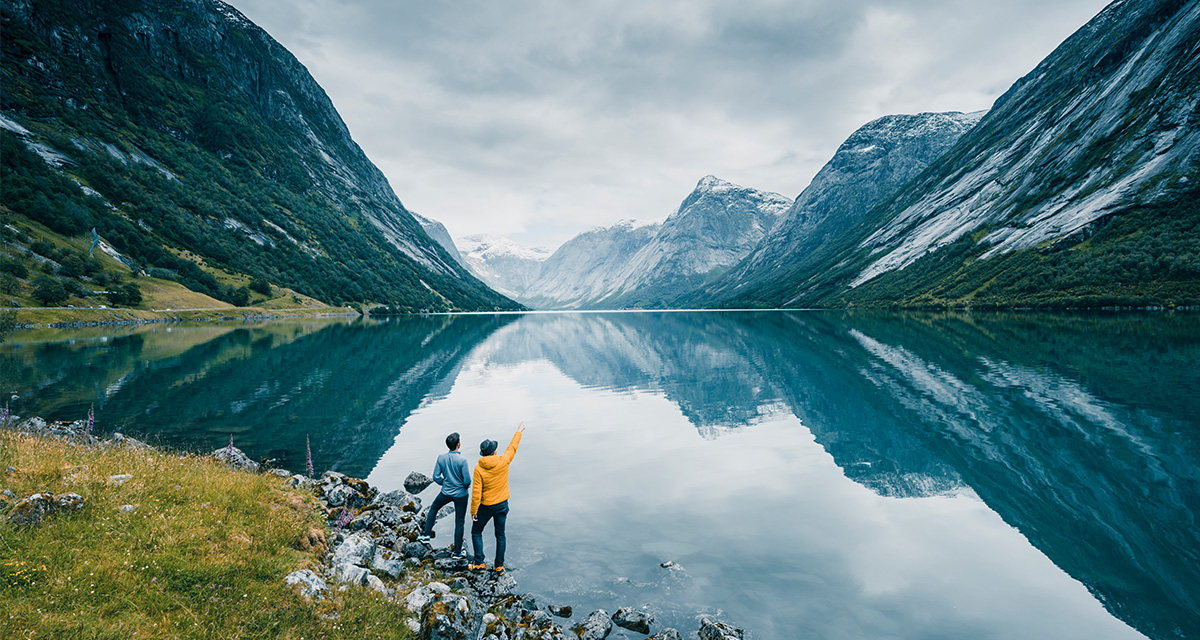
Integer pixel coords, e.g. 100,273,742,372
724,183,1200,309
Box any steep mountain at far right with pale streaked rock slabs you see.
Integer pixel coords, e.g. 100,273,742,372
721,0,1200,306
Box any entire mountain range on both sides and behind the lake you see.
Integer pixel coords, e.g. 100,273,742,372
0,0,1200,311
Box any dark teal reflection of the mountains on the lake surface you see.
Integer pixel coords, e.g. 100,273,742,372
0,312,1200,638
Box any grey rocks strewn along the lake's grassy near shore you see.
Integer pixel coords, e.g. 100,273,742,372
6,418,745,640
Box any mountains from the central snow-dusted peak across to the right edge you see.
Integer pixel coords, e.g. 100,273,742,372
463,0,1200,309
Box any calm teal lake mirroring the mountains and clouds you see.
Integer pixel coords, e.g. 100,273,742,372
0,312,1200,640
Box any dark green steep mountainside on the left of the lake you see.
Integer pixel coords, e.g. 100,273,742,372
0,0,515,309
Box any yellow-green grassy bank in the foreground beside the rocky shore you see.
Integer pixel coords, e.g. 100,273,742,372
0,431,412,639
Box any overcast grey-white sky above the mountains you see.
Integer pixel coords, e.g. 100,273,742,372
230,0,1108,249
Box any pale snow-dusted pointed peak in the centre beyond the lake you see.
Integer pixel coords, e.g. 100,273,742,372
518,175,792,309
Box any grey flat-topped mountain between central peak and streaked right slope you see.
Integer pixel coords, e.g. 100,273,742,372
686,112,985,304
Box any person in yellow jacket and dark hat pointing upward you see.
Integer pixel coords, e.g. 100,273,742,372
469,423,524,573
